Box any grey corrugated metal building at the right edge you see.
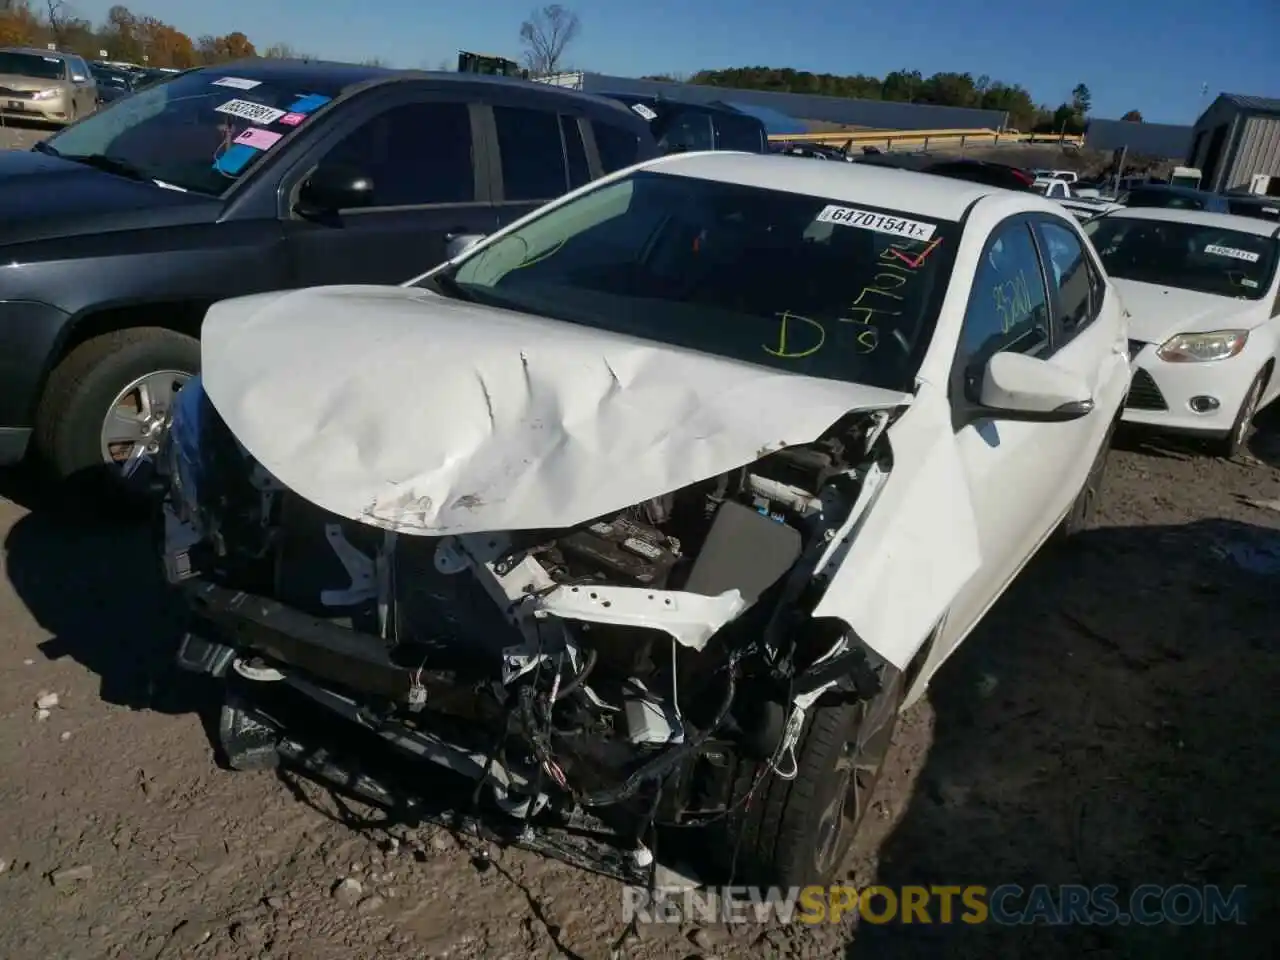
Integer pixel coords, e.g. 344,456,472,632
1187,93,1280,191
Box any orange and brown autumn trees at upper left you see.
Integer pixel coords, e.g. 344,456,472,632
0,0,374,69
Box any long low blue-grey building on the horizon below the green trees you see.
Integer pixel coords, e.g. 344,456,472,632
582,73,1005,131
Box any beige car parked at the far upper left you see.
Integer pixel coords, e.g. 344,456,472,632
0,47,97,127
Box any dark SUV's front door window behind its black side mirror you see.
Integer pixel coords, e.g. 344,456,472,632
314,102,475,207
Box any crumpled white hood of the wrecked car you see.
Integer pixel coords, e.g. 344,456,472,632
201,287,911,536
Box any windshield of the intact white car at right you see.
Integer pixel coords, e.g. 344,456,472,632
1084,216,1280,300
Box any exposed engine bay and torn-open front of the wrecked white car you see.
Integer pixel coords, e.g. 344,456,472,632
163,389,891,880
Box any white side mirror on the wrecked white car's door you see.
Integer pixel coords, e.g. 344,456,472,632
974,353,1093,424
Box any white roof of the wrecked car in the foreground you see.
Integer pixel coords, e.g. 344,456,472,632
653,151,993,221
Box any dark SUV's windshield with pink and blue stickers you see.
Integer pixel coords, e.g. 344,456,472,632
40,70,339,196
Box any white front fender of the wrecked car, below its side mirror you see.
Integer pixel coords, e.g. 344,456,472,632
813,385,982,671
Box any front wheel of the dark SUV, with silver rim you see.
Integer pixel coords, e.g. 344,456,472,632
36,326,200,499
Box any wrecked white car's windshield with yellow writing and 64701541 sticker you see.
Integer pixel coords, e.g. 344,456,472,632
435,172,959,389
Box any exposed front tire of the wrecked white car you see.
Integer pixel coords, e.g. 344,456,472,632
717,666,906,888
